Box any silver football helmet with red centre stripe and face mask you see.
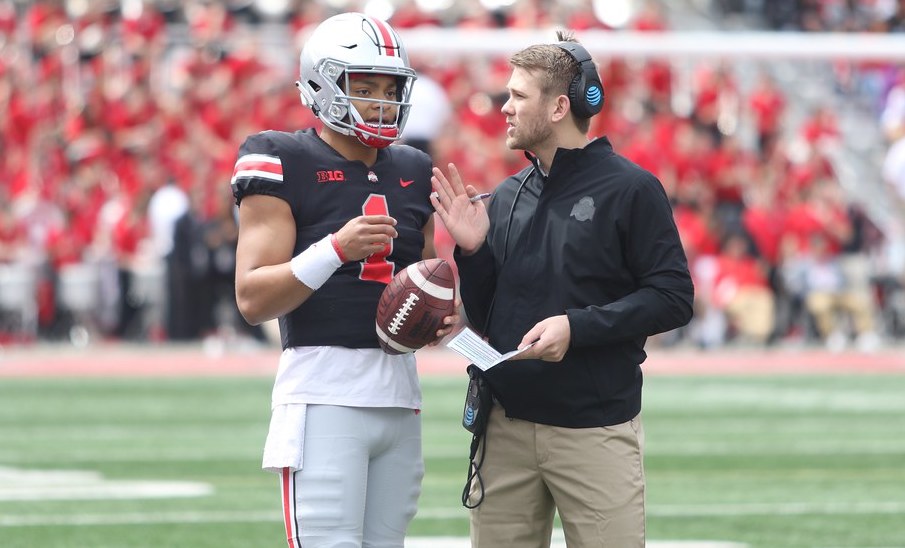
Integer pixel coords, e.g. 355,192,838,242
296,13,416,148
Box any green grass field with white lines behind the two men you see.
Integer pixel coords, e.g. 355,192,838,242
0,374,905,548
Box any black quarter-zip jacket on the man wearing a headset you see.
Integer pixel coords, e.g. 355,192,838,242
454,137,694,428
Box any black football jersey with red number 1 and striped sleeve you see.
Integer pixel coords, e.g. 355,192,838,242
232,129,433,349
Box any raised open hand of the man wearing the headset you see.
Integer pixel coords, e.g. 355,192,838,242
431,163,490,255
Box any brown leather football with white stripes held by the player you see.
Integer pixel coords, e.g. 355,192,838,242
377,259,456,354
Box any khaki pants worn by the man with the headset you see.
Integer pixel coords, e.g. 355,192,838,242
471,404,645,548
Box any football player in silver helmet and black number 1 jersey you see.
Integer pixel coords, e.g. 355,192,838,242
232,13,457,548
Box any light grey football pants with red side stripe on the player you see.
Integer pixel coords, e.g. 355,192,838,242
280,405,424,548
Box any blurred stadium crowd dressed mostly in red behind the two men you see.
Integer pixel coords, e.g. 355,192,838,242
0,0,905,350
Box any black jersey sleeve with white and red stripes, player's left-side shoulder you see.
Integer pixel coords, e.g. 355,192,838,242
230,132,286,205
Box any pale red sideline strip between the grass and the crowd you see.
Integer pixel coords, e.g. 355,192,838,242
0,342,905,378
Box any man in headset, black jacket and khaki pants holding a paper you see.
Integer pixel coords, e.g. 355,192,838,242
432,32,694,548
